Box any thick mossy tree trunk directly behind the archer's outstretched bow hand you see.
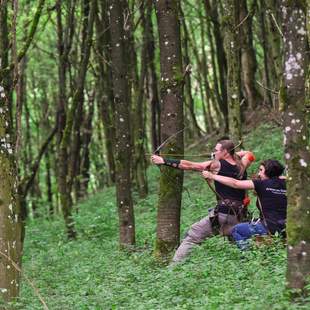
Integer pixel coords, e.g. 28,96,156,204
155,0,184,258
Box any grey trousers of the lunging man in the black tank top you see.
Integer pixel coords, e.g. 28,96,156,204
172,213,239,262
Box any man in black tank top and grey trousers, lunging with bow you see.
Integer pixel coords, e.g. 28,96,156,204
151,139,255,262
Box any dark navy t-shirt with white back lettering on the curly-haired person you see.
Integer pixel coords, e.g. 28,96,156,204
253,178,287,234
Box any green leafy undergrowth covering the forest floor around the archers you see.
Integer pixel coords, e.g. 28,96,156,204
8,125,310,310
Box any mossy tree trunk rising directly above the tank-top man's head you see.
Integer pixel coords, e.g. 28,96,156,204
222,0,241,142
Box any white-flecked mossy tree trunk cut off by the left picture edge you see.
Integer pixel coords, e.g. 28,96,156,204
0,1,22,301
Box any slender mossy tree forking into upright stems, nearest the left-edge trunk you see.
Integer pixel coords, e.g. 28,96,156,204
57,0,96,239
